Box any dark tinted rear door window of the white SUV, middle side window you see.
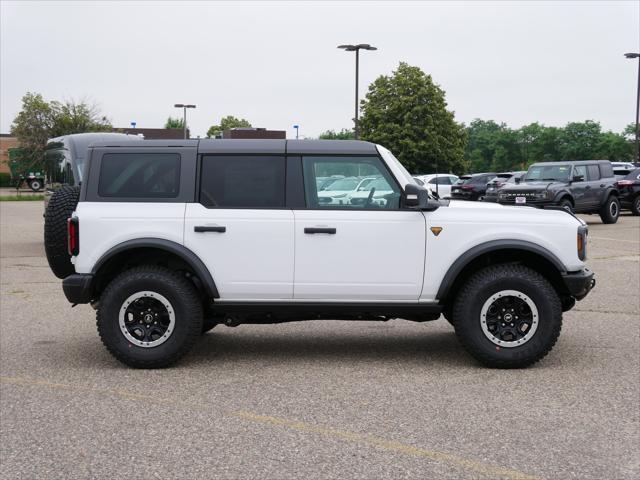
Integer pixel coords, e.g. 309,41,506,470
200,156,285,208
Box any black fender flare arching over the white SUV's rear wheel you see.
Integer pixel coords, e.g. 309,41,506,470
91,238,220,298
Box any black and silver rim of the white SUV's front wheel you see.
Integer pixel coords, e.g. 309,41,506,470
480,290,539,348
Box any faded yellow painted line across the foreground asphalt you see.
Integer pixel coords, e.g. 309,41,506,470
0,376,538,480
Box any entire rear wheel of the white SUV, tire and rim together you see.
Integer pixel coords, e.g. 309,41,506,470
97,265,202,368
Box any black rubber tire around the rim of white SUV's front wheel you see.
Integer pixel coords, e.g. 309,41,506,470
453,264,562,368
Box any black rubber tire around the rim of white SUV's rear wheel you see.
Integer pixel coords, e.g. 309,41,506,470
96,265,202,368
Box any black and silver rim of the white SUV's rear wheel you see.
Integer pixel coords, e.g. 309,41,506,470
118,290,176,348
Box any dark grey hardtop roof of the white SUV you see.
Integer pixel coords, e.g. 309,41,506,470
87,139,378,155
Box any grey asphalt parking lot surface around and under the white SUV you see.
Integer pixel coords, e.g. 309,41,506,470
0,202,640,480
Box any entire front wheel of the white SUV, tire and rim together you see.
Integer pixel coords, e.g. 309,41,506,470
453,265,562,368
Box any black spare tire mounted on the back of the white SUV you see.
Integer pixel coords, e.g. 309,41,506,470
44,186,80,278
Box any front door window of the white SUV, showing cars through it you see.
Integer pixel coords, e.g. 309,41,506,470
302,156,400,209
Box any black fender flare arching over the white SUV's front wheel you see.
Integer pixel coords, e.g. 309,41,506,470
436,240,566,301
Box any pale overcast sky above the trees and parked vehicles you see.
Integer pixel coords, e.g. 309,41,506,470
0,1,640,137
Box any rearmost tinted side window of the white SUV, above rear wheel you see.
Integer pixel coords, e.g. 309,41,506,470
98,153,180,198
